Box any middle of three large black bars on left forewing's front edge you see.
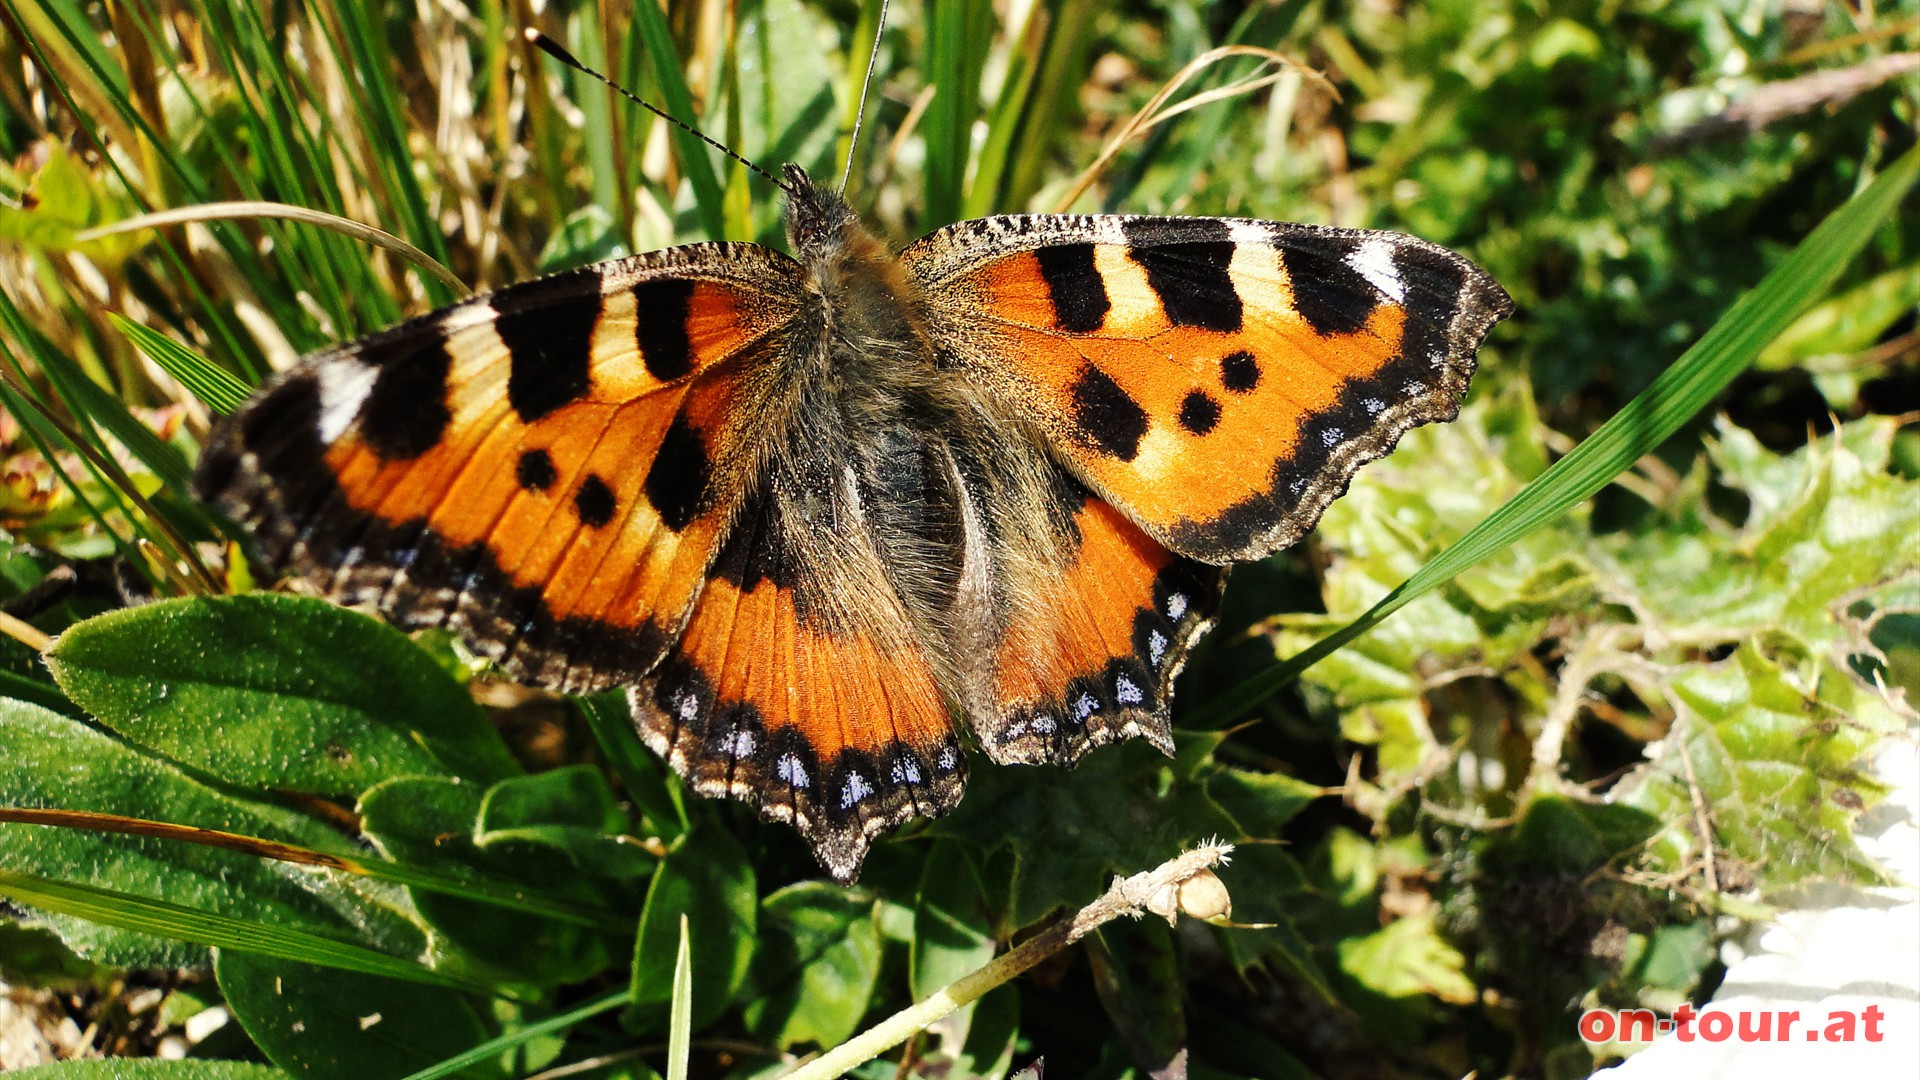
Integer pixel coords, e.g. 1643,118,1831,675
493,269,601,423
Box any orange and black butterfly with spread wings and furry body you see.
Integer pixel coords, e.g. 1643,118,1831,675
196,165,1513,882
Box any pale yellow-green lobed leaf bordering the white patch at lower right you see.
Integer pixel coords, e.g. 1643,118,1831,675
1615,646,1901,892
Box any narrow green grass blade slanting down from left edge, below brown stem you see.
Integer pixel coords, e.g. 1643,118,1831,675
0,871,503,997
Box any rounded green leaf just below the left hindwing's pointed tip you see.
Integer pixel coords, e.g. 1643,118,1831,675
741,882,879,1049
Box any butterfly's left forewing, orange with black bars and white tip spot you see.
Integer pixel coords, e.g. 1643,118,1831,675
194,244,801,692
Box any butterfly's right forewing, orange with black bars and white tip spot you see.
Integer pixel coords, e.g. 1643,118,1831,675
900,215,1513,563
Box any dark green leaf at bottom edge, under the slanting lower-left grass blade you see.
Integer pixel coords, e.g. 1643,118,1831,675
213,949,510,1080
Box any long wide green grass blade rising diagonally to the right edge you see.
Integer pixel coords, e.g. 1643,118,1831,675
1190,148,1920,726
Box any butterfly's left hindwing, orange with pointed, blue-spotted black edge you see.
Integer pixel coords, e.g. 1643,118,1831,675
632,457,966,884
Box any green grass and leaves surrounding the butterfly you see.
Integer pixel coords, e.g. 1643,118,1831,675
0,0,1920,1080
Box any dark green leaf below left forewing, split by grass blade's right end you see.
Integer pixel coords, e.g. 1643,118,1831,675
359,776,632,986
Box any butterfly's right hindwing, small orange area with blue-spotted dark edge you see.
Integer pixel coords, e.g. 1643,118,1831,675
973,473,1227,765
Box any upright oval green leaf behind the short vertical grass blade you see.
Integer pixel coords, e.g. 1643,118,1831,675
624,826,760,1030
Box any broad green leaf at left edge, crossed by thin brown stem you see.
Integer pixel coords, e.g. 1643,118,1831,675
0,700,424,967
